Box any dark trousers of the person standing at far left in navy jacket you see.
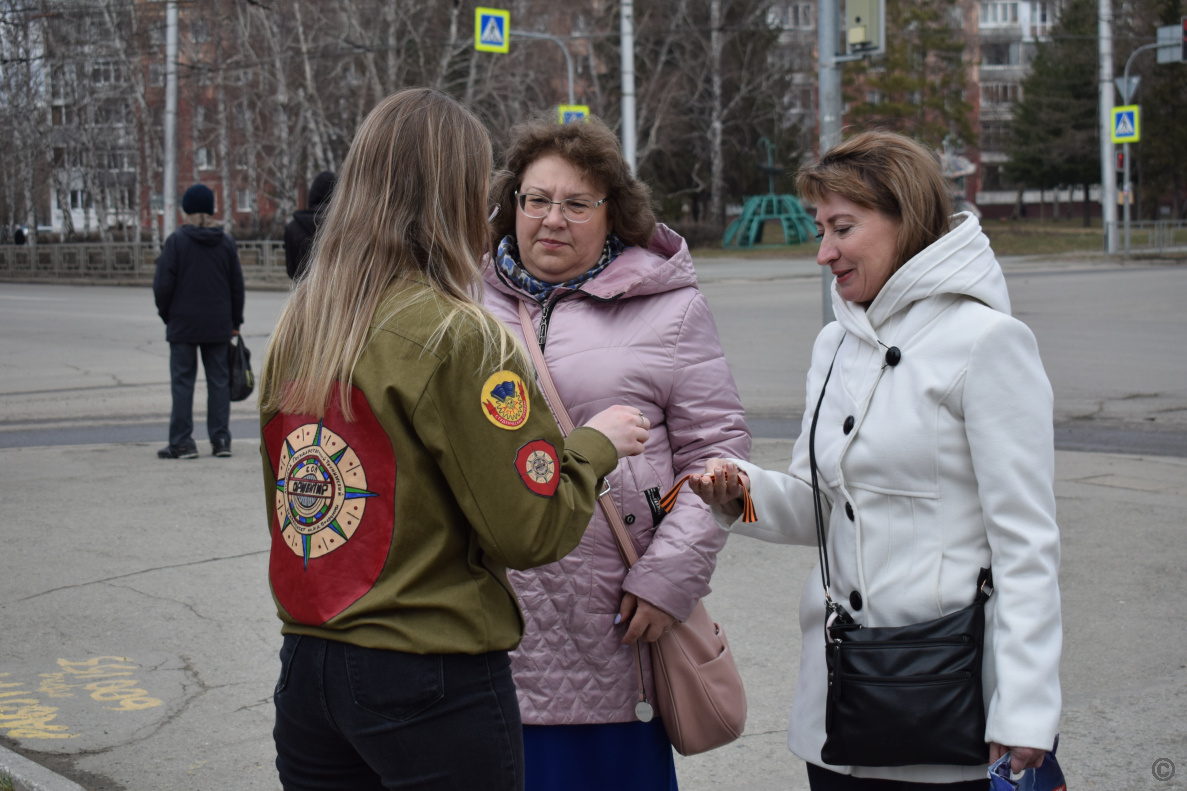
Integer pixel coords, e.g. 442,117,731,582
169,343,230,447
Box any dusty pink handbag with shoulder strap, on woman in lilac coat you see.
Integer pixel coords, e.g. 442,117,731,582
519,302,747,755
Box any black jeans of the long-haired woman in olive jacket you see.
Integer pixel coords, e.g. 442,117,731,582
272,634,523,791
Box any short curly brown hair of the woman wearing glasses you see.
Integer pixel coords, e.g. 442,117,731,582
490,115,655,247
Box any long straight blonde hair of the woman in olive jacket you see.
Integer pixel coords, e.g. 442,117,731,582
260,88,526,420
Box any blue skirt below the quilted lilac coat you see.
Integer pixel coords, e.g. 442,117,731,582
523,720,677,791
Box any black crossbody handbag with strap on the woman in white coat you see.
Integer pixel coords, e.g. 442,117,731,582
808,339,994,766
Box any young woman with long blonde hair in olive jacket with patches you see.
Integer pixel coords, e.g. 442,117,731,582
260,89,647,790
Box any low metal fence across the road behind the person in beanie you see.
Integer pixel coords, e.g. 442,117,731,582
0,241,288,283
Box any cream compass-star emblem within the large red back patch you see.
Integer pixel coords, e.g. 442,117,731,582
275,423,375,565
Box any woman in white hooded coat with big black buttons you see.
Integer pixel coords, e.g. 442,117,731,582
691,132,1062,791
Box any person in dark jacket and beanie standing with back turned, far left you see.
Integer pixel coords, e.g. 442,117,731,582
152,184,243,458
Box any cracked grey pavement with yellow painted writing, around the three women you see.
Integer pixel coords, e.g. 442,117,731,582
0,441,1187,791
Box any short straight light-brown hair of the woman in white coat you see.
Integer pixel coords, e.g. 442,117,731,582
795,132,952,271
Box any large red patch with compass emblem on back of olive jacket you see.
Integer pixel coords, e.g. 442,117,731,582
264,387,395,626
